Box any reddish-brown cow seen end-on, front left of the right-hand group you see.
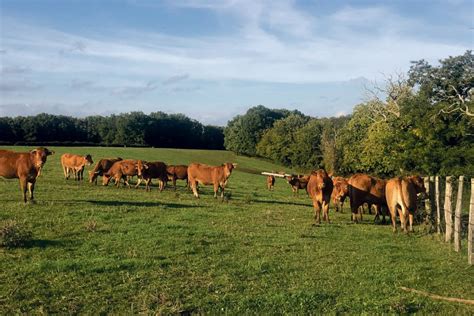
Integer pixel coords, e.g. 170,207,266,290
306,169,333,224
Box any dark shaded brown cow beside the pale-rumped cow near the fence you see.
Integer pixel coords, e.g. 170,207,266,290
347,173,387,222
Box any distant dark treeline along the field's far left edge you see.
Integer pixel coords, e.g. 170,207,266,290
0,112,224,149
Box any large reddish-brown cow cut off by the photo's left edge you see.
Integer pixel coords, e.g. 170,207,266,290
0,147,54,203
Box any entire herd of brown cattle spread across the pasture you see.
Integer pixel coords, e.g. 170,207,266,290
0,147,426,232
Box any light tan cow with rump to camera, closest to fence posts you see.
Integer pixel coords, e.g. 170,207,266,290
385,176,426,232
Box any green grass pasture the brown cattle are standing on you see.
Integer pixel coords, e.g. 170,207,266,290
0,148,474,315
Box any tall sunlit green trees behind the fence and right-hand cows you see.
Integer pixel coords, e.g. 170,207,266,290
224,51,474,176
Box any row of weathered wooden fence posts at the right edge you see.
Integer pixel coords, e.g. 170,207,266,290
424,176,474,265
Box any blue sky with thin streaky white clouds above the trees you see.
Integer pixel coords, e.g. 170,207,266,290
0,0,474,125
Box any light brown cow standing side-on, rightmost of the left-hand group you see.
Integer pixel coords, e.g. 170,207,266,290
188,162,237,199
